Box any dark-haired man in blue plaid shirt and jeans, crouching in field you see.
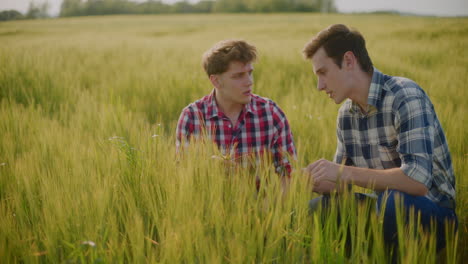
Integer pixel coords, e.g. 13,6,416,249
303,24,458,252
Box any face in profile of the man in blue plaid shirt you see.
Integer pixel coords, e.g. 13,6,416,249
312,47,349,104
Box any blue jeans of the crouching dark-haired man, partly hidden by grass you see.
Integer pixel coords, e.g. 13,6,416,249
309,190,458,251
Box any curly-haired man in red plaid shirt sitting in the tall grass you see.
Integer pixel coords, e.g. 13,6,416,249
176,40,296,177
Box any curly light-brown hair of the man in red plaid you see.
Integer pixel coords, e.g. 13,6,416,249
202,39,257,76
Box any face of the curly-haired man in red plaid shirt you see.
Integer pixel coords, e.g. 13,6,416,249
215,61,253,104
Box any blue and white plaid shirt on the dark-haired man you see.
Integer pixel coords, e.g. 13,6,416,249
334,68,455,202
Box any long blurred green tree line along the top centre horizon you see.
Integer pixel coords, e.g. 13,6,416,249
60,0,336,16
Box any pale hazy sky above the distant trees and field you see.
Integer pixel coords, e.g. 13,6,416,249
0,0,468,16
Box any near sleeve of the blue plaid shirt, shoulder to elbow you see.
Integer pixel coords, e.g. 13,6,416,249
395,96,435,188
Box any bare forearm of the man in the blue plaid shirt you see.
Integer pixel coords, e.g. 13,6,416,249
342,166,427,196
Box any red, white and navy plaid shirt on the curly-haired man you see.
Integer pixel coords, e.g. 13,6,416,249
176,90,296,176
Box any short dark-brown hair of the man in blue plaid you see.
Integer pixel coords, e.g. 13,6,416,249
302,24,373,73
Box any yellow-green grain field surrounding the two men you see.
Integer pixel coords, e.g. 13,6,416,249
0,14,468,263
